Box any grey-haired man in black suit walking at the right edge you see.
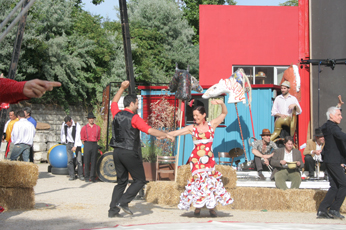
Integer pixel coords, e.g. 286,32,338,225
317,107,346,219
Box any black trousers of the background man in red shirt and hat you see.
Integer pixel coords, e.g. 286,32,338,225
84,141,98,180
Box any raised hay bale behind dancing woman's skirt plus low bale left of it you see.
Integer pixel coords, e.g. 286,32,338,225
145,165,237,206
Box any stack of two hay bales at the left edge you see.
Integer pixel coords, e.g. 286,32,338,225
0,160,38,210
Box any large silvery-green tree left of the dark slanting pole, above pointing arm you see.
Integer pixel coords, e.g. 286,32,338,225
0,0,126,106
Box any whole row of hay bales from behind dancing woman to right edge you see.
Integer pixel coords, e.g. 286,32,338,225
146,165,346,213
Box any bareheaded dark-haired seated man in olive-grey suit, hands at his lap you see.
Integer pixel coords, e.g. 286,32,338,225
270,136,304,190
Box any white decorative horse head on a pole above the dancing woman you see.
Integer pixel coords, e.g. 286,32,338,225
202,69,251,104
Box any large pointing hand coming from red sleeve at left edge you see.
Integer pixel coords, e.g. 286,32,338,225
23,79,61,98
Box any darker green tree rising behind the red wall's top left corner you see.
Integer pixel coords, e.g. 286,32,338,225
183,0,237,44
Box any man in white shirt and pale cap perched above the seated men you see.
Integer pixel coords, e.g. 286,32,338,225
271,81,302,141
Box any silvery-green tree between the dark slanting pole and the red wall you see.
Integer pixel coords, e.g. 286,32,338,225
128,0,199,83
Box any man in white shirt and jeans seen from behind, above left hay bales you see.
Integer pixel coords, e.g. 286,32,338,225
10,110,36,162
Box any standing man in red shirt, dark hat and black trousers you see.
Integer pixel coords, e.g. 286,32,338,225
80,112,101,183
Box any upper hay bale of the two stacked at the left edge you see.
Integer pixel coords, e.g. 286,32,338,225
0,160,38,188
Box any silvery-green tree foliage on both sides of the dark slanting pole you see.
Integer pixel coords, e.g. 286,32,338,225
0,0,199,108
